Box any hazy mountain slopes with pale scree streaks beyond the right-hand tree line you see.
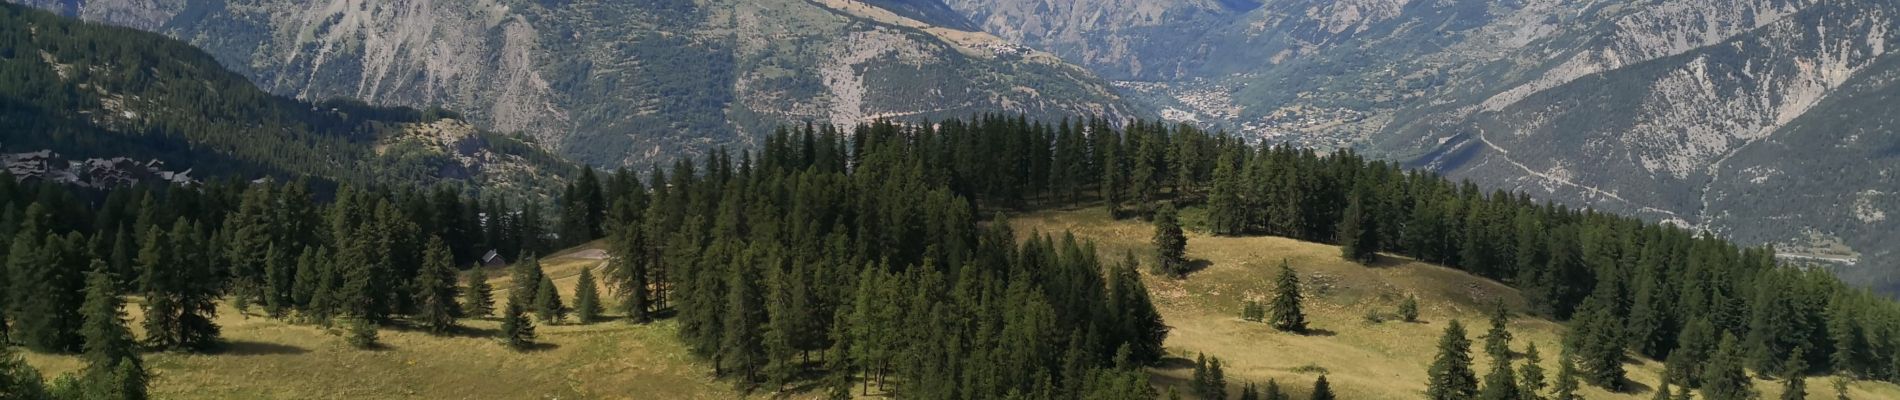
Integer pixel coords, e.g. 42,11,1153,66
946,0,1900,284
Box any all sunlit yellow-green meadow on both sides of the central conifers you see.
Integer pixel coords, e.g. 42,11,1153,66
14,209,1900,400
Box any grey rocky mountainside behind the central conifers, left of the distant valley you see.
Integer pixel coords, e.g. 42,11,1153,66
13,0,1134,167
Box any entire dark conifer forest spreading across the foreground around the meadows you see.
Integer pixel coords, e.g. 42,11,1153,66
11,116,1900,398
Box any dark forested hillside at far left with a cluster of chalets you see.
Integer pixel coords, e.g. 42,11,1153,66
0,4,572,198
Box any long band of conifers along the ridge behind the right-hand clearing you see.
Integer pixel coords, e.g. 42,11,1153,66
861,116,1900,392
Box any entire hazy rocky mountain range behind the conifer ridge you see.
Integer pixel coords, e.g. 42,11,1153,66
25,0,1900,288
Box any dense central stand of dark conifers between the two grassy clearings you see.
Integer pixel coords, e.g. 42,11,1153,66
602,125,1167,398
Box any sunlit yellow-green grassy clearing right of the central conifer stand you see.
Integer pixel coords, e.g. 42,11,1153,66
1013,209,1900,400
